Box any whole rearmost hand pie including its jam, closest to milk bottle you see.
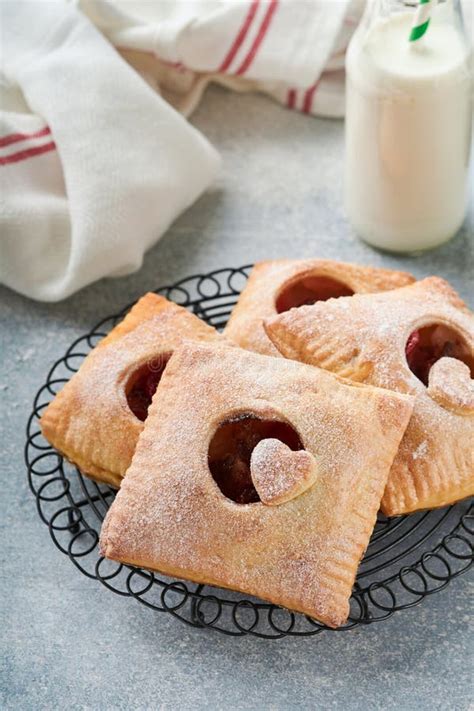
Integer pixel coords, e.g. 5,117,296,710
224,259,414,356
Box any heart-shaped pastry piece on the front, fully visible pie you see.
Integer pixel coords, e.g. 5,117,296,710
250,439,317,506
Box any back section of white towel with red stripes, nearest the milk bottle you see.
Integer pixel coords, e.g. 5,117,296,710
81,0,365,117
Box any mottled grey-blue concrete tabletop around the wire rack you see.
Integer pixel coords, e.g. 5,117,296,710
0,89,474,711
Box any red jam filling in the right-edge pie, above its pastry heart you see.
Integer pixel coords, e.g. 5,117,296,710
405,324,474,385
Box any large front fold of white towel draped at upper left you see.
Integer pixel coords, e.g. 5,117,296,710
0,0,219,301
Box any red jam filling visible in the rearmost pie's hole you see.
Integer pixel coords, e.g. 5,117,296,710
275,275,354,314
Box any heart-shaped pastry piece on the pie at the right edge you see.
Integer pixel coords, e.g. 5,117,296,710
428,358,474,415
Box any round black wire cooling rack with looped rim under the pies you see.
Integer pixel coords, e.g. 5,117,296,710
25,266,474,639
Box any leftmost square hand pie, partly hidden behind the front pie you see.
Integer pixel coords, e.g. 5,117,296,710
40,293,222,487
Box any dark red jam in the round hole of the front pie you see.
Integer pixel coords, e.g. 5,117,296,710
208,415,304,504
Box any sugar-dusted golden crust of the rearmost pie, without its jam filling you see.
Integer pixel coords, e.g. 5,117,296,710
224,259,415,356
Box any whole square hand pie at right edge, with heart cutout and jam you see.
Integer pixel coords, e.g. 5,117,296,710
266,277,474,516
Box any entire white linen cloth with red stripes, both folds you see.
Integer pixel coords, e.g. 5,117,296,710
0,0,361,301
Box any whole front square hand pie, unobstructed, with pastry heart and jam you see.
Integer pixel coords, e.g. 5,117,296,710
101,343,412,627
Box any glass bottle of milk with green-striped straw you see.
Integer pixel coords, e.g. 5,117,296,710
345,0,472,252
